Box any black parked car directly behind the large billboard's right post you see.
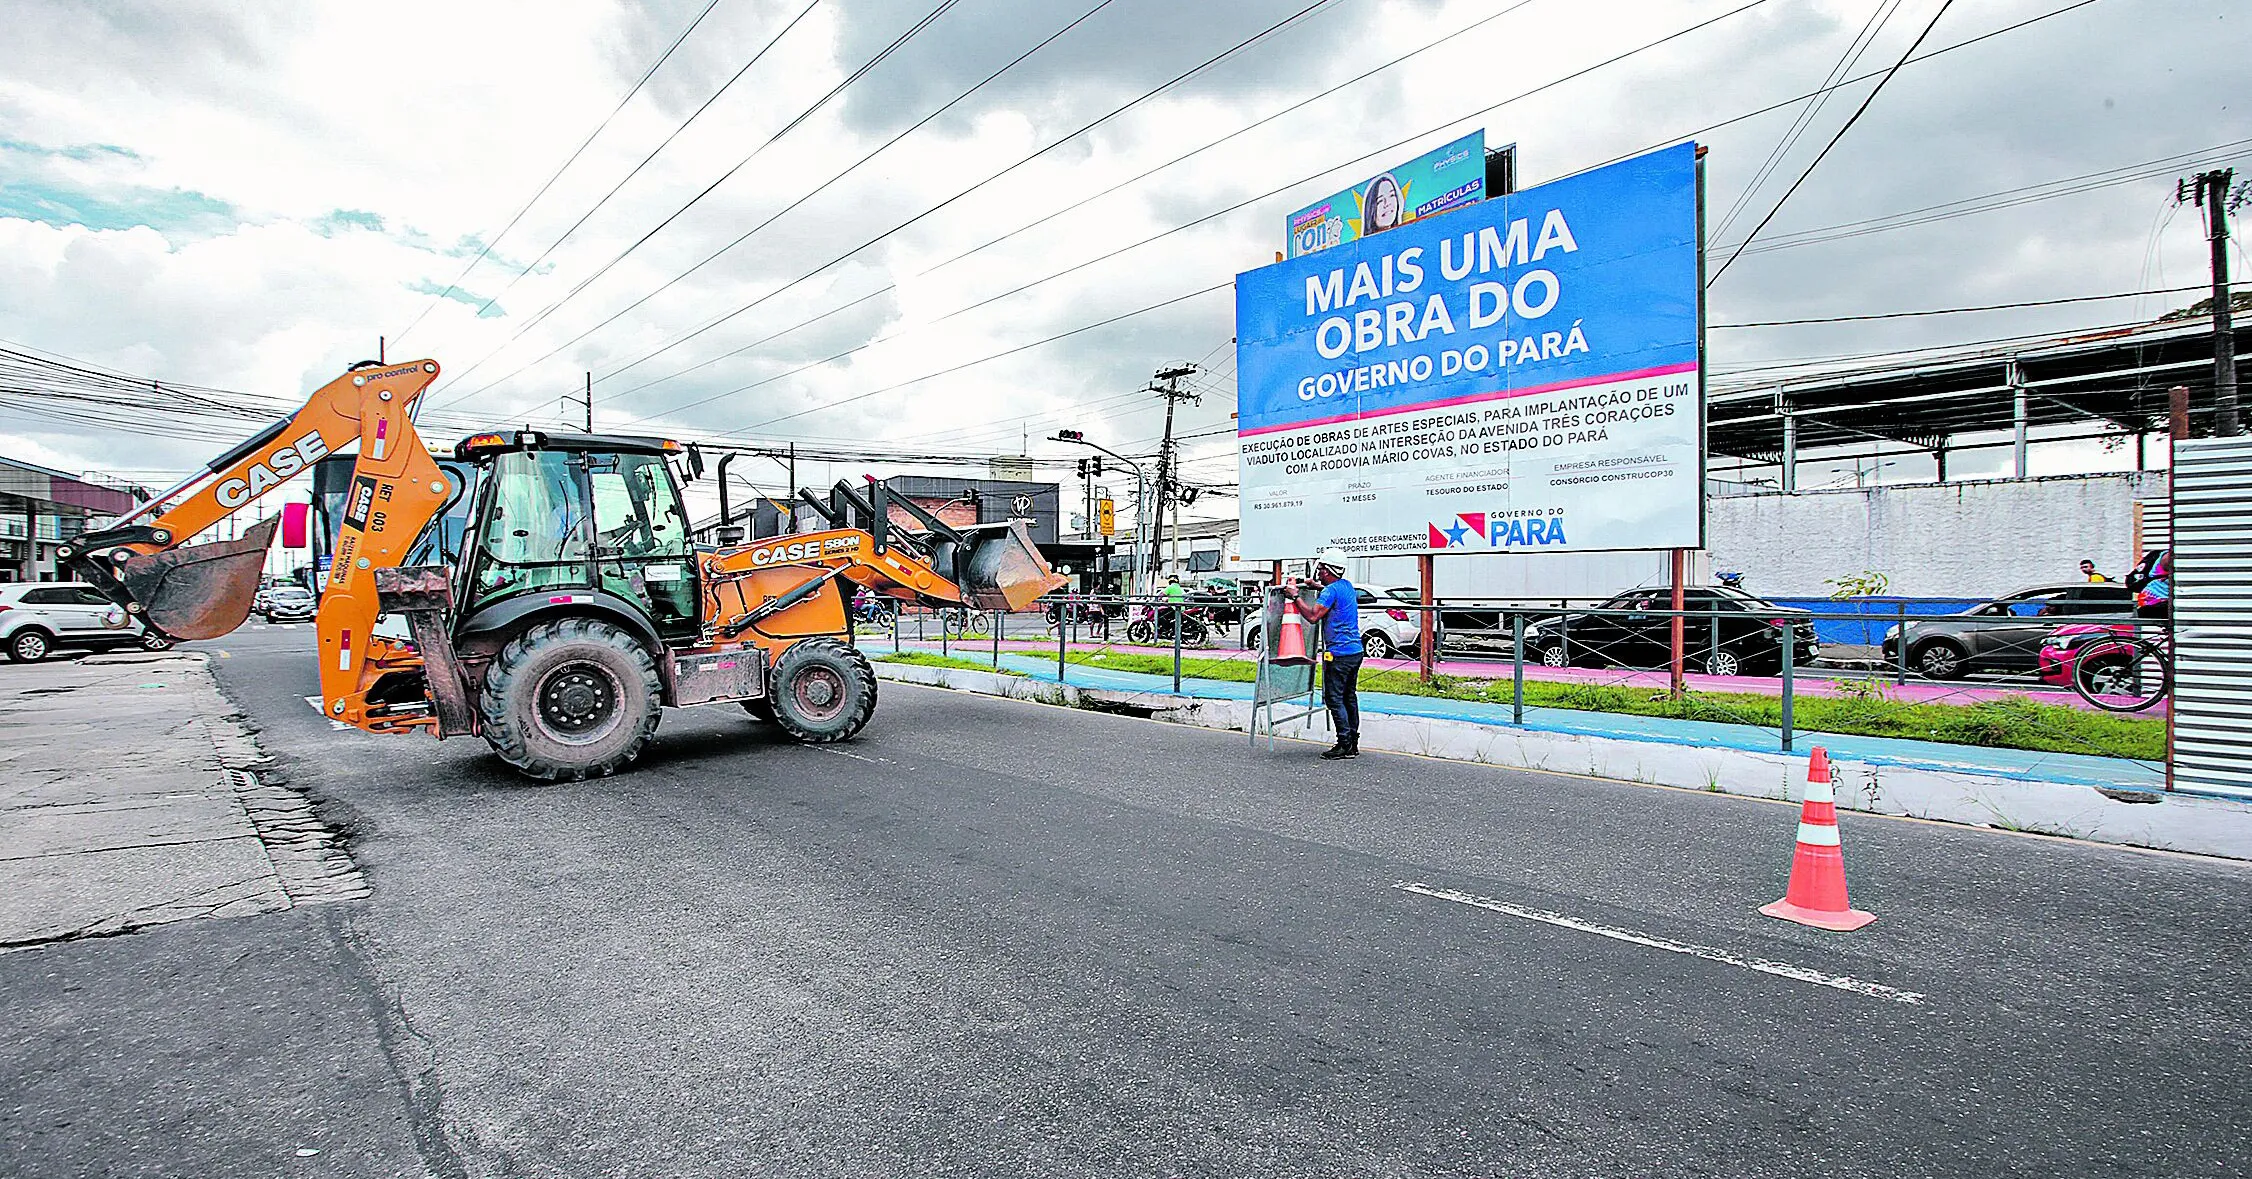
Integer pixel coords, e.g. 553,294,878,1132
1525,587,1822,675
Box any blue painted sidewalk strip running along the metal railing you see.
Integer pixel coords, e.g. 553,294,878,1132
863,644,2166,790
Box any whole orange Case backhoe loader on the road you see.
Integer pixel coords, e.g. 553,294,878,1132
63,360,1063,781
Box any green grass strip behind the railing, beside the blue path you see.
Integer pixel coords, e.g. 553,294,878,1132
1070,653,2166,761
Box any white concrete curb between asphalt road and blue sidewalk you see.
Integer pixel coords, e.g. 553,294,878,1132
876,659,2252,860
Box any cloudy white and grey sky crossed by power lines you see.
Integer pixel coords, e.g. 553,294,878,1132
0,0,2252,513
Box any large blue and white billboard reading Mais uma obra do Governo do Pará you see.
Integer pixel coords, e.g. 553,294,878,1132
1236,144,1705,560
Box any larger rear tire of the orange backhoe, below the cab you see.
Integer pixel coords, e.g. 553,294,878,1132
477,619,662,781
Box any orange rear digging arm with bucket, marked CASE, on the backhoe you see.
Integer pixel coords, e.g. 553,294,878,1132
63,360,446,729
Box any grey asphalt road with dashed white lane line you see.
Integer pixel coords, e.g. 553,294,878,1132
0,628,2252,1177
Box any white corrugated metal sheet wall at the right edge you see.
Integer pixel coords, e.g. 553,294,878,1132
2173,437,2252,799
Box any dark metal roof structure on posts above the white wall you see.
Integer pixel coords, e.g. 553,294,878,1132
1705,317,2252,484
